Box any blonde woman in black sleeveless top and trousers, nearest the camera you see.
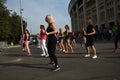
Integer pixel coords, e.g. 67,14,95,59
45,15,60,71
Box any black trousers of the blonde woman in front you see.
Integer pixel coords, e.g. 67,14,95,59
48,37,58,66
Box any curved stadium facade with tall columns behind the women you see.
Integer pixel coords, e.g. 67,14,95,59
68,0,120,31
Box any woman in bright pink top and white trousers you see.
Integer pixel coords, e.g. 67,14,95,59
40,25,49,57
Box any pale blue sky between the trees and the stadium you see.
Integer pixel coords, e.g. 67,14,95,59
6,0,71,34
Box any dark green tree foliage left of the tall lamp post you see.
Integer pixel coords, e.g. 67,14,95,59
0,0,25,43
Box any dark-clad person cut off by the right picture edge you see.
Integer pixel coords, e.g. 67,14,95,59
114,19,120,53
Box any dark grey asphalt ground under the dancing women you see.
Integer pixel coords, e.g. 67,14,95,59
0,41,120,80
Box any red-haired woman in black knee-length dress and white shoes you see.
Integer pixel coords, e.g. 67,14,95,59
83,19,97,59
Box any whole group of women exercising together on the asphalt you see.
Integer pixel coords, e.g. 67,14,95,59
18,15,120,71
